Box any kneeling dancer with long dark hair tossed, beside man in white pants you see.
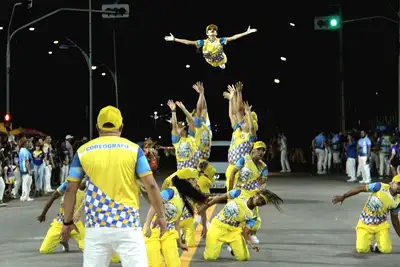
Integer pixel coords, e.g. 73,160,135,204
142,176,207,267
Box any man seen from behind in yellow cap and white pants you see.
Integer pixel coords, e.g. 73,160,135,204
62,106,166,267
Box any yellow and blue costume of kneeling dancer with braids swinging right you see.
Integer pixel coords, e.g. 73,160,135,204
204,189,256,261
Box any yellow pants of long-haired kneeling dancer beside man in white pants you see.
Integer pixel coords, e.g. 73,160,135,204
143,227,181,267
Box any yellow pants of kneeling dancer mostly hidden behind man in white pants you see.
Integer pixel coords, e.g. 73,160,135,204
39,220,120,263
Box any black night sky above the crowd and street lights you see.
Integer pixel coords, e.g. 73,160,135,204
0,0,398,147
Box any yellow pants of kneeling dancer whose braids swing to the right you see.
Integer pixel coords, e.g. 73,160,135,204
204,218,250,261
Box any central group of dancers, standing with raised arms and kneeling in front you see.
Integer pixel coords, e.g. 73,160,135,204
142,82,283,267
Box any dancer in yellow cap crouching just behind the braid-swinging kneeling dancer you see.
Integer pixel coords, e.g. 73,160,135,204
228,141,268,250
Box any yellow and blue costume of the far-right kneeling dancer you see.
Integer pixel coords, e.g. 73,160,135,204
356,181,400,253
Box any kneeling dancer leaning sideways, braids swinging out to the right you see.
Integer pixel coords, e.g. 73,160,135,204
199,188,283,261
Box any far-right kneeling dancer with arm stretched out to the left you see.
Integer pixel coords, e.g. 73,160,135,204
332,175,400,254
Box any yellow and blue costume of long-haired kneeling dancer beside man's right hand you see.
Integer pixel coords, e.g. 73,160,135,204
144,186,184,267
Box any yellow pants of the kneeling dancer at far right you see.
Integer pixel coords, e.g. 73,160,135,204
356,222,392,254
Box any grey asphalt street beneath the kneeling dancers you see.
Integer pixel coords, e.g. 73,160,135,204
0,174,400,267
